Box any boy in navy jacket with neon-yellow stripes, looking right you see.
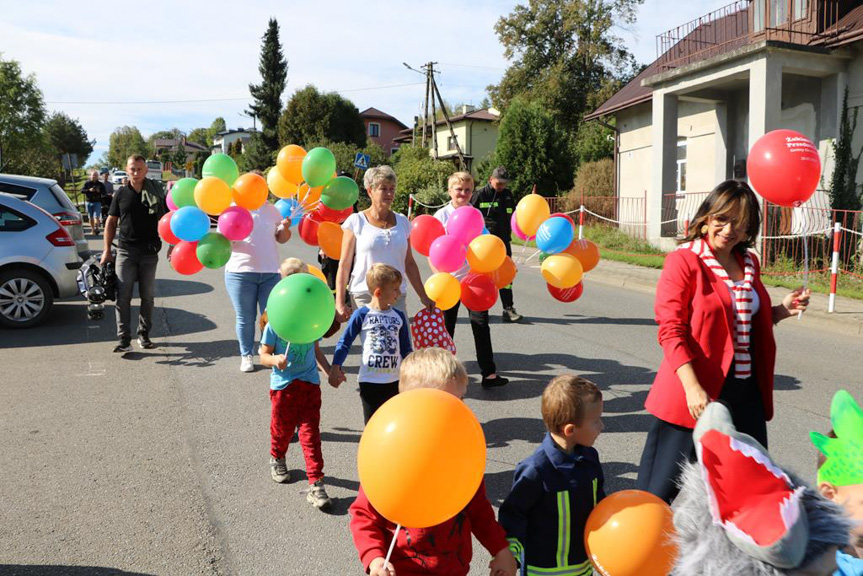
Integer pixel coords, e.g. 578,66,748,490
498,374,605,576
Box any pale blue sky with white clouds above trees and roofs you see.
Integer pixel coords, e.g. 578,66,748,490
0,0,716,162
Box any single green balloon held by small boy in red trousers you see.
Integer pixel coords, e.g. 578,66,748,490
267,273,336,344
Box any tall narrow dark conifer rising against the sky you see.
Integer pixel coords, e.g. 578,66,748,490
248,18,288,152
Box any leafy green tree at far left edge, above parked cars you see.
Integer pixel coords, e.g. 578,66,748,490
0,57,46,172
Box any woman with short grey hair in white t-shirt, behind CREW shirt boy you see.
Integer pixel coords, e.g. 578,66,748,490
336,166,434,322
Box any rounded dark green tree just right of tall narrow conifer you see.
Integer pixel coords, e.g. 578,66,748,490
279,85,366,148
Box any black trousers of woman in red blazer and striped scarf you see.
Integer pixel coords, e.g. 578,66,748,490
636,366,767,504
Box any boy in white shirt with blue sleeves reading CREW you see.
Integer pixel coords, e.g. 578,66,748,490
330,264,412,423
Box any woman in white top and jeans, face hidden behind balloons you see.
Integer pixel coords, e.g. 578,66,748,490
225,202,291,372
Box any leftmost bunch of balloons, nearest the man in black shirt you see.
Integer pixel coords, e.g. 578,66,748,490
159,154,269,274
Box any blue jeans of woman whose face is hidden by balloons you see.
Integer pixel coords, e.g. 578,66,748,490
225,272,281,356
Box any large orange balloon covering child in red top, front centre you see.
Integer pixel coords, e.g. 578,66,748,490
357,388,485,528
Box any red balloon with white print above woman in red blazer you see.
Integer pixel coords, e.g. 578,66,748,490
746,130,821,207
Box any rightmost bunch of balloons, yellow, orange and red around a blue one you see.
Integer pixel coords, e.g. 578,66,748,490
510,194,599,302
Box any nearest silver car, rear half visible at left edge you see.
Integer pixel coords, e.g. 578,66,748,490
0,193,83,328
